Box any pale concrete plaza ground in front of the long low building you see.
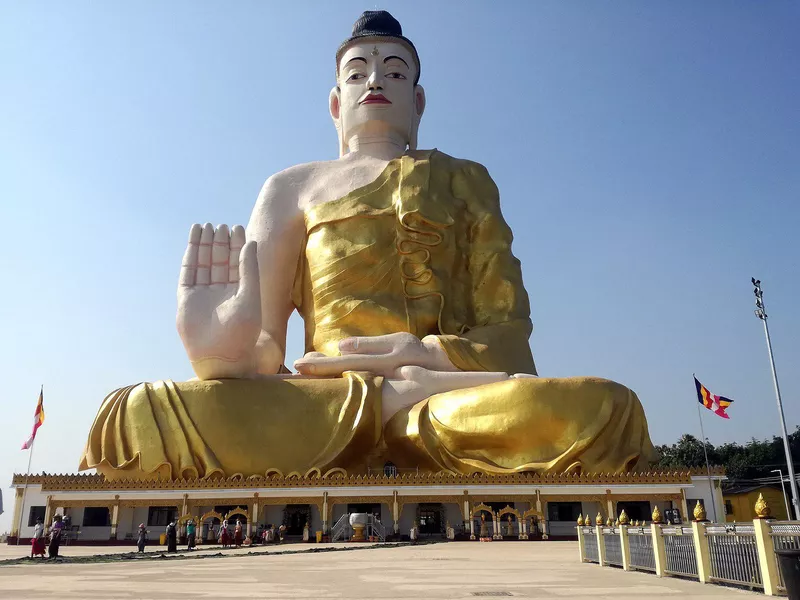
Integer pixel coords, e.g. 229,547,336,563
0,542,755,600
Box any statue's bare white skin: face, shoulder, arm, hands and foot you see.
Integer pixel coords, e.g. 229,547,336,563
177,41,526,423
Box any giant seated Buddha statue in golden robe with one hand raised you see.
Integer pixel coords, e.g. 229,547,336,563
81,11,654,479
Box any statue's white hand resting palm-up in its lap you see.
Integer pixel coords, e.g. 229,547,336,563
294,332,458,377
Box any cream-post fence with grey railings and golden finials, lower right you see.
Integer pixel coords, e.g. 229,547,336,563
577,519,800,596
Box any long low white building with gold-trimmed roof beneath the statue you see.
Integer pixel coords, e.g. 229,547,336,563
12,465,725,543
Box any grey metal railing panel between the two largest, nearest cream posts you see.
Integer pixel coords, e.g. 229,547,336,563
705,523,764,587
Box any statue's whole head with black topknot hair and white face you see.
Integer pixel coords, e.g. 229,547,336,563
329,10,425,156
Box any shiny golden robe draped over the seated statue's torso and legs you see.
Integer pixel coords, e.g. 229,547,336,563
80,150,654,478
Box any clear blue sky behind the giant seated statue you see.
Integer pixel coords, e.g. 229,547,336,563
0,0,800,531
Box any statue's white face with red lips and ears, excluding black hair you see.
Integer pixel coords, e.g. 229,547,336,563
330,39,425,154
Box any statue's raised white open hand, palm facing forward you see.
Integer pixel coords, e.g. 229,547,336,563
177,223,261,379
